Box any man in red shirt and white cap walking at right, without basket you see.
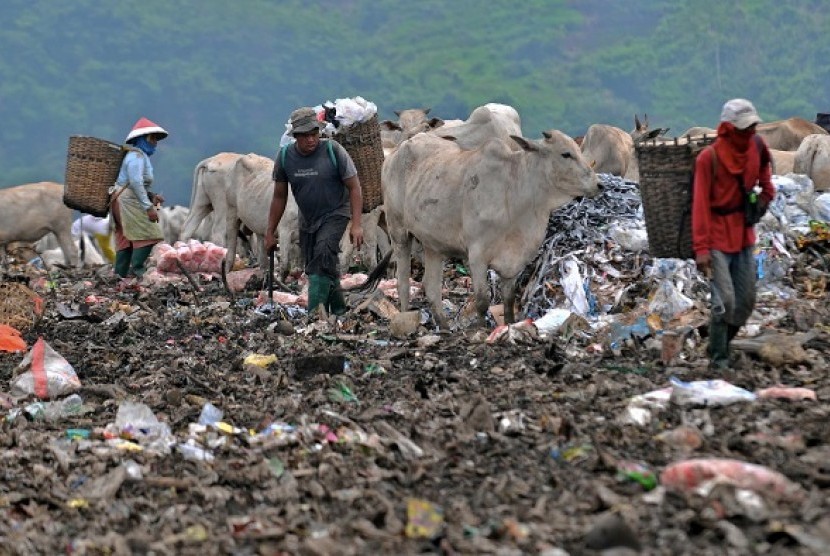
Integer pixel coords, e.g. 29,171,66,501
692,98,775,370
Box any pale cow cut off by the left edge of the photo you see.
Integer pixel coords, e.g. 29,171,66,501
0,182,79,266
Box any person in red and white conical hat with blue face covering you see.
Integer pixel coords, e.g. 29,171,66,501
111,118,168,278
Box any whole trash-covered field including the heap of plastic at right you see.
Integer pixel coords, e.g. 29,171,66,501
0,177,830,556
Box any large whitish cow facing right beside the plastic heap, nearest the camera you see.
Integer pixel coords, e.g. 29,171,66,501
382,130,599,327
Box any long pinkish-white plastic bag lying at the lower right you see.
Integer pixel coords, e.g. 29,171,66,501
660,458,804,500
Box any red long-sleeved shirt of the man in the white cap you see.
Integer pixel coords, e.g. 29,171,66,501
692,140,775,255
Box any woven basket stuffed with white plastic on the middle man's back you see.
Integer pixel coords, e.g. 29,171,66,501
334,114,383,212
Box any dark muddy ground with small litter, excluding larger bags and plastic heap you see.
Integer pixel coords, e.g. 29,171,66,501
0,256,830,555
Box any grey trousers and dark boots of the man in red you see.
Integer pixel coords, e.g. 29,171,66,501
709,247,756,368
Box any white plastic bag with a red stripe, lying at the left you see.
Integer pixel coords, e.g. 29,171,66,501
10,337,81,400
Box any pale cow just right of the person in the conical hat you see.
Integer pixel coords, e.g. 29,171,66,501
179,152,242,245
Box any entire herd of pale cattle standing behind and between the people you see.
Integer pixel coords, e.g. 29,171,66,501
0,103,830,323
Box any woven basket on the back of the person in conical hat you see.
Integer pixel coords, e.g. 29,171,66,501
63,135,125,216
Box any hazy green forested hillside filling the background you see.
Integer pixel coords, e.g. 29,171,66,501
0,0,830,205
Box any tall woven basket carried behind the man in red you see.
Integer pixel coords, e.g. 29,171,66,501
635,136,715,259
